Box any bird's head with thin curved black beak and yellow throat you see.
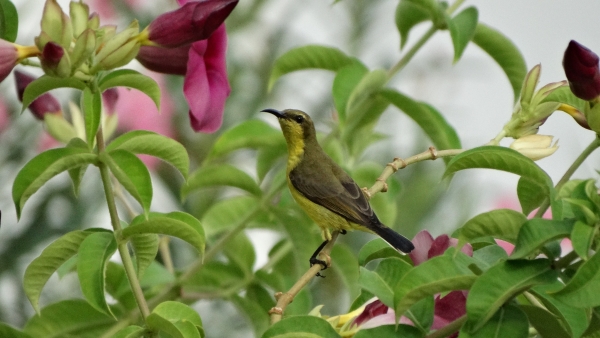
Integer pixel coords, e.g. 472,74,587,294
261,109,316,146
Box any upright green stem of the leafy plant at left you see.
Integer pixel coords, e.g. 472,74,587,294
96,127,150,320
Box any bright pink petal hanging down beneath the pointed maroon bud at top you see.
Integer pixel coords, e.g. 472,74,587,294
183,25,231,133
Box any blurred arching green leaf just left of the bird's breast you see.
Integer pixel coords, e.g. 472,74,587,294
181,164,262,198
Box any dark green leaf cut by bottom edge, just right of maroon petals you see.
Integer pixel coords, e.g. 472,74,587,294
460,305,529,338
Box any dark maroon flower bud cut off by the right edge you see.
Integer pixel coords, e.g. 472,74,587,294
563,40,600,101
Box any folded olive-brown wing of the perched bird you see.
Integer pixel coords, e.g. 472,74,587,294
289,165,373,226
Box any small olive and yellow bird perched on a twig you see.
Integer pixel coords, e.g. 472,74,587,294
261,108,415,275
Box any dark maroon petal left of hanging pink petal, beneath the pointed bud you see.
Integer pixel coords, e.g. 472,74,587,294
135,45,191,75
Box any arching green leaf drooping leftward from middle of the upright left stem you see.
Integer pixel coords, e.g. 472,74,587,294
12,148,97,218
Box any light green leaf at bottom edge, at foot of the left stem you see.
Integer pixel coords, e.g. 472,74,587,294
146,301,204,338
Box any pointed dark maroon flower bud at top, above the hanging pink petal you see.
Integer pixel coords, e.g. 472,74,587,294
147,0,238,47
